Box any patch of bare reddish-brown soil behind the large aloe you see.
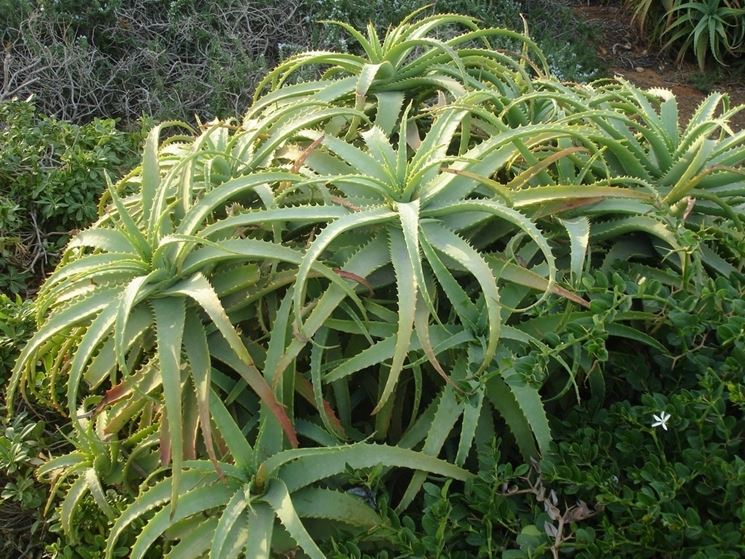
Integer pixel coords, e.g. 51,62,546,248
573,2,745,130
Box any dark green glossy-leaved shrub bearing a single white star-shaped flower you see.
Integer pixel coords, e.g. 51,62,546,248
325,270,745,559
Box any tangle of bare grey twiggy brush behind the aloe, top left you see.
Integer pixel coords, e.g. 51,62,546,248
0,0,303,121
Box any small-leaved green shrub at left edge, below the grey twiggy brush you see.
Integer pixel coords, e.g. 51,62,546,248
0,101,140,293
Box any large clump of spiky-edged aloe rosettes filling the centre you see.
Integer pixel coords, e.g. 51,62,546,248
11,8,743,557
